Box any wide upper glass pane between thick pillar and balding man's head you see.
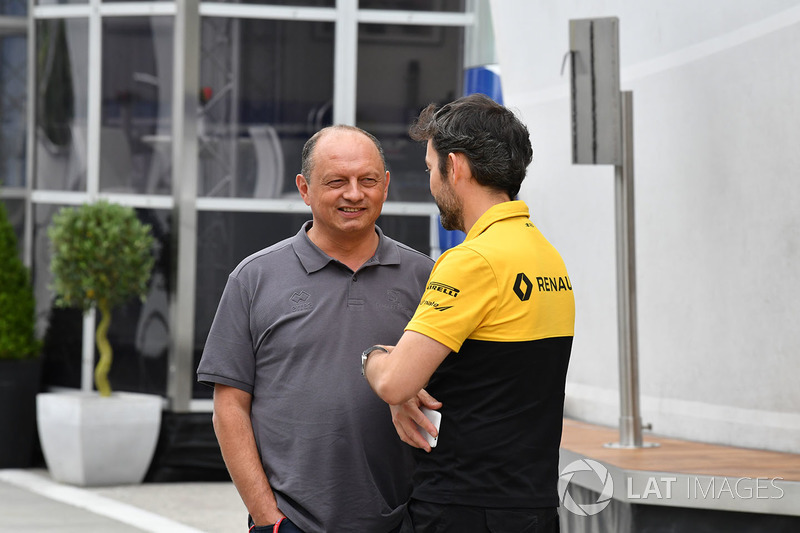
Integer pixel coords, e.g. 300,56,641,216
198,18,333,199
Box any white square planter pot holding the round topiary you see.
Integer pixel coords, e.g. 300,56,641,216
36,391,162,486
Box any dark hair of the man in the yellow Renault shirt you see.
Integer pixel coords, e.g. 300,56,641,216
408,94,533,199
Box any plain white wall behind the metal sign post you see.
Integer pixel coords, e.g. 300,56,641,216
492,0,800,453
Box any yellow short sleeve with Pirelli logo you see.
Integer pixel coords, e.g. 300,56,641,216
406,247,498,352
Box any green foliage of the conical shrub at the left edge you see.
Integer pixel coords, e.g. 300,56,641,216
0,202,41,359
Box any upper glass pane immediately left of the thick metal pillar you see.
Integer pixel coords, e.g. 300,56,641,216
100,17,173,194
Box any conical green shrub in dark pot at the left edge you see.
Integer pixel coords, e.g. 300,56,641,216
0,202,41,468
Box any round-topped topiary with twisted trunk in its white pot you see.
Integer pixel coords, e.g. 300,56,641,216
37,197,162,485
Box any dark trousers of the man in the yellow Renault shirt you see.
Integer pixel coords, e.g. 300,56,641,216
408,499,560,533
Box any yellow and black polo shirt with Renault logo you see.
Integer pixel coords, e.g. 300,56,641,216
406,201,575,508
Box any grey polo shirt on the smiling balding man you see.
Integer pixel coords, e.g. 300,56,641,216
197,222,433,533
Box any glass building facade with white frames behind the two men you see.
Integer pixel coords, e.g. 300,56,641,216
0,0,486,412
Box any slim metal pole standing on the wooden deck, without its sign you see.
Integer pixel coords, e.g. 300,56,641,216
611,91,643,448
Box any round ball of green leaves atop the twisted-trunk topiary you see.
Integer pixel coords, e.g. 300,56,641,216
47,201,155,311
